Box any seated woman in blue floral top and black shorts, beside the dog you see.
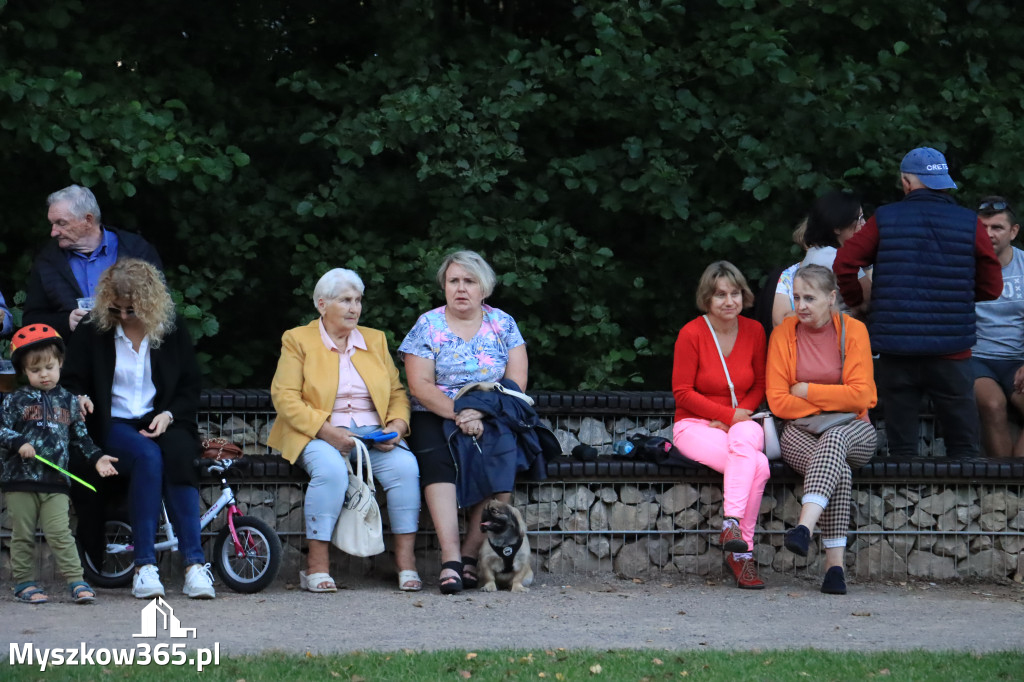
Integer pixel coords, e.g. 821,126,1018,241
398,251,528,594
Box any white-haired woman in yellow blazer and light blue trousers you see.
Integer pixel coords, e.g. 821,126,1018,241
269,268,422,592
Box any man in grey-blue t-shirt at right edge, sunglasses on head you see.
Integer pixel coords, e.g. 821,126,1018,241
971,197,1024,457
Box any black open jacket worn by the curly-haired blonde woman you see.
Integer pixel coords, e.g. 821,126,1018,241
60,315,200,485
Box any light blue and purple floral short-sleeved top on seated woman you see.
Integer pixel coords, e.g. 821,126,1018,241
398,305,526,412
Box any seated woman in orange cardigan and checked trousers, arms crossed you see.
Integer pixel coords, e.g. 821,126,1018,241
766,265,878,594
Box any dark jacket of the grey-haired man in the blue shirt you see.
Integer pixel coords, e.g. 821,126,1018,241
22,225,161,337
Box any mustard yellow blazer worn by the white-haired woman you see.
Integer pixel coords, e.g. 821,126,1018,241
267,318,409,464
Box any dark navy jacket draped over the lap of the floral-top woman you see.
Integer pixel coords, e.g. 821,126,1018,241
444,379,561,507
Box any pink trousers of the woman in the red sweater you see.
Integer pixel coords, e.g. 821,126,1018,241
672,419,769,548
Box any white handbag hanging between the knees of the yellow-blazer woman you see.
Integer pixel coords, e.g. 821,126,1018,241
331,438,384,556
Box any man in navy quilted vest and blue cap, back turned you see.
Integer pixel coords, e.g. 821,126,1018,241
833,146,1002,457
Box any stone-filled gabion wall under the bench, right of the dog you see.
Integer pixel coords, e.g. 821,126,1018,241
516,482,1024,581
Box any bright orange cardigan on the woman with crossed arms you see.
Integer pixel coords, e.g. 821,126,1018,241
765,312,879,419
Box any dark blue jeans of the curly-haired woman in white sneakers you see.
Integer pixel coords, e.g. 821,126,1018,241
105,422,206,566
